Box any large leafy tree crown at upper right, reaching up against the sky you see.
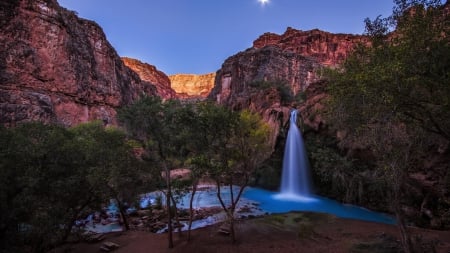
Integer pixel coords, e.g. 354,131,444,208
328,1,450,140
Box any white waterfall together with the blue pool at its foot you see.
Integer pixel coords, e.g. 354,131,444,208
244,110,395,224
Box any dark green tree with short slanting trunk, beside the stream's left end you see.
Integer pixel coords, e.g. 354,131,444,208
69,121,148,230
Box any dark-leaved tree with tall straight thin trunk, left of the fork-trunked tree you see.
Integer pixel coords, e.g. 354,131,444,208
118,97,190,248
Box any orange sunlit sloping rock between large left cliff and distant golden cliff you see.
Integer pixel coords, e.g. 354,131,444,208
122,57,176,99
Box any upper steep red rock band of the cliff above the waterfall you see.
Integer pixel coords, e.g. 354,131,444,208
210,27,368,103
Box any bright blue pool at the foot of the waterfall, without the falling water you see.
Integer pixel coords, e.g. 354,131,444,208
243,188,395,224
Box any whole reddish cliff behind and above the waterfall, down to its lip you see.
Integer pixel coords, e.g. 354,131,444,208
209,28,368,146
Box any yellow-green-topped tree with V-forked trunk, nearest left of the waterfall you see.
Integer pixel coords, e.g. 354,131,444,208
211,110,270,242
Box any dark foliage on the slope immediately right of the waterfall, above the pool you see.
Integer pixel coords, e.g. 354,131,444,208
305,133,388,211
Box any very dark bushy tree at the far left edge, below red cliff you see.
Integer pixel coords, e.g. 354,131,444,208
1,123,96,252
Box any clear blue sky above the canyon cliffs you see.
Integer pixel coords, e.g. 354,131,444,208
58,0,393,75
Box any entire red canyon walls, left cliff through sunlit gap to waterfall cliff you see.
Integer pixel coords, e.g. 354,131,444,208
0,0,448,231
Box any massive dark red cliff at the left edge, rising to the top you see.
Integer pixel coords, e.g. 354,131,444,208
0,0,156,126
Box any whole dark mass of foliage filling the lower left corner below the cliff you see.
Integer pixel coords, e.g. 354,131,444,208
0,123,143,252
